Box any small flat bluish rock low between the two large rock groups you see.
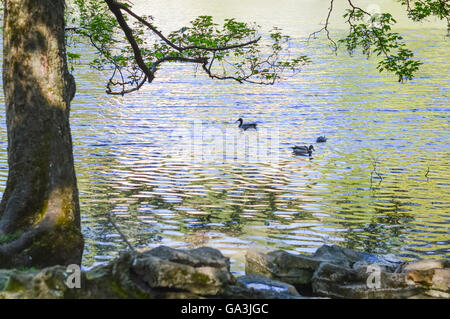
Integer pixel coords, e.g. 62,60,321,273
237,275,301,299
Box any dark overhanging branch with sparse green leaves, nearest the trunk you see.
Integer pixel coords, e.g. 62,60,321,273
96,0,307,95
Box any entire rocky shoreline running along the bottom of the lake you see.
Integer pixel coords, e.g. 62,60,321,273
0,245,450,299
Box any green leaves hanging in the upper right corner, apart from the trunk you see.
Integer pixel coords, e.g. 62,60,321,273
310,0,450,82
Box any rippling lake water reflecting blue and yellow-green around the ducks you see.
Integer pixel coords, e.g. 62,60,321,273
0,0,450,273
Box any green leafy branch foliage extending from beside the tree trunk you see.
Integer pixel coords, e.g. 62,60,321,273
68,0,309,94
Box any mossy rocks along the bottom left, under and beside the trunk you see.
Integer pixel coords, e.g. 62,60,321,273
0,246,239,298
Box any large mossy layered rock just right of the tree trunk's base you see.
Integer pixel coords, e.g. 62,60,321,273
86,246,236,298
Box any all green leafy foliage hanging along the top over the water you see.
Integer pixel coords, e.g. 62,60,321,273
61,0,450,90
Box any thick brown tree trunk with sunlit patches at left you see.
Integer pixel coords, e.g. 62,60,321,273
0,0,83,268
